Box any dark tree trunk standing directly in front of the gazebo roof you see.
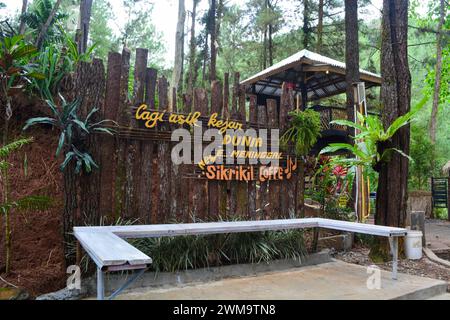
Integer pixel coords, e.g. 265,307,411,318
345,0,360,131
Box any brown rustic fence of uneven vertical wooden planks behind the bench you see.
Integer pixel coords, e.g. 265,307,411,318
65,49,304,231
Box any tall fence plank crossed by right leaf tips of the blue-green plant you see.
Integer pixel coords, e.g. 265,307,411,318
100,52,122,218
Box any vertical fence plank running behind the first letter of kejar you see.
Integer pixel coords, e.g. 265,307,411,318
208,81,223,221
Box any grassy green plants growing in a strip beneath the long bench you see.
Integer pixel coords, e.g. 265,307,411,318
130,231,306,272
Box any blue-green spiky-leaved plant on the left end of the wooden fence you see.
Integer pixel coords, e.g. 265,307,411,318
23,95,115,174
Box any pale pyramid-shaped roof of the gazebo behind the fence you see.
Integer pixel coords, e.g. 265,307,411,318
241,50,381,101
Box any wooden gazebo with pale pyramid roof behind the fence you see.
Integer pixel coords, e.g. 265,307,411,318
241,50,381,151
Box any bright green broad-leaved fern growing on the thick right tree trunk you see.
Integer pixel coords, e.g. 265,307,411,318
320,111,417,171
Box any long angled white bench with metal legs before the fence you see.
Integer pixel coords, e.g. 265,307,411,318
74,218,407,300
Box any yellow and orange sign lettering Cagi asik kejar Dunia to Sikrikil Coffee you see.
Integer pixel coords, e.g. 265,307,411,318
135,104,298,182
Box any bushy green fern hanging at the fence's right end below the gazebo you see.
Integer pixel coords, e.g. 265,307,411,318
281,109,322,157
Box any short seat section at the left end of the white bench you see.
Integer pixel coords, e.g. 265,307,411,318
75,231,152,268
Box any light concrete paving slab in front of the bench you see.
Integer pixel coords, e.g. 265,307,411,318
118,261,447,300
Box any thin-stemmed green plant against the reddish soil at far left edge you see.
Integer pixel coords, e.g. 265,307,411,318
0,138,51,274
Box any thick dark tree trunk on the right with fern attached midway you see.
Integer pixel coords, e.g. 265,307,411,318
375,0,411,227
